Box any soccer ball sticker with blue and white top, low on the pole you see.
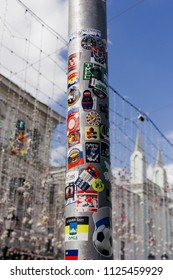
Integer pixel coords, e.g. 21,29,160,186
92,207,113,257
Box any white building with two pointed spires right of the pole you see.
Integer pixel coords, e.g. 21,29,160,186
112,131,173,260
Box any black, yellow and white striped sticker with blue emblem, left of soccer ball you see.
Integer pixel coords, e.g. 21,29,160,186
65,217,89,241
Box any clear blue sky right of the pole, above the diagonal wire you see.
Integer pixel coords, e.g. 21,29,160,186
108,0,173,135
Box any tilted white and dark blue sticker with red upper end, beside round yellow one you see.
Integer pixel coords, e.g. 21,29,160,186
75,164,100,191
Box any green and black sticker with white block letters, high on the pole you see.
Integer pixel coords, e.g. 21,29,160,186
83,62,104,80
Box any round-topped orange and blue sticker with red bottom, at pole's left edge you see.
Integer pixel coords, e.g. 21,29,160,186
68,145,84,169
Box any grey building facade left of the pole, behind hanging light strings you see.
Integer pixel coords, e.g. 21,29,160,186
0,75,64,258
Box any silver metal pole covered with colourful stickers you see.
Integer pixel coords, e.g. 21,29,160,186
65,0,113,260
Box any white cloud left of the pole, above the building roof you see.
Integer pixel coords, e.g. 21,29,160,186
0,0,68,111
